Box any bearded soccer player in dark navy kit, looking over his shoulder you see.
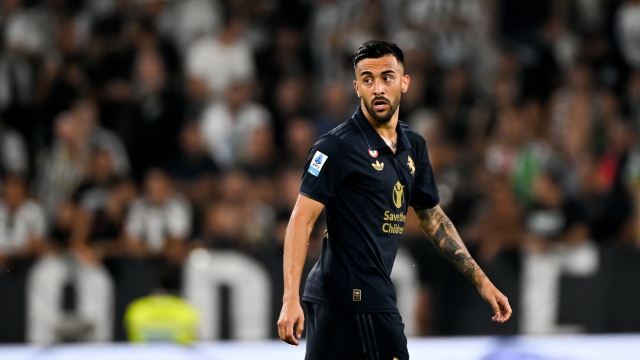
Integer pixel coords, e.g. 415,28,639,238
278,41,511,360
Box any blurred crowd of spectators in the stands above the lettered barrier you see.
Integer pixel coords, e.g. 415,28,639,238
0,0,640,340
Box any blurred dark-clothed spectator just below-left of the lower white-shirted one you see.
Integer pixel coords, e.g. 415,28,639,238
169,122,220,204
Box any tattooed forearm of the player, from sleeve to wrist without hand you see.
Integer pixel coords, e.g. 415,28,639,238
417,206,484,285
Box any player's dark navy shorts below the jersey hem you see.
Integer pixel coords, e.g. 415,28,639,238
305,302,409,360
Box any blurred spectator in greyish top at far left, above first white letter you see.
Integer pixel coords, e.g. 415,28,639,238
34,112,90,219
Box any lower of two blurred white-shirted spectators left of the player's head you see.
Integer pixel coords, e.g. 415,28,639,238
200,82,271,169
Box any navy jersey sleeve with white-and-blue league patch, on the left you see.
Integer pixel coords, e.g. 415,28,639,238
300,135,349,205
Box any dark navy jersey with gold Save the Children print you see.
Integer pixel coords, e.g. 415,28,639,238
300,109,440,312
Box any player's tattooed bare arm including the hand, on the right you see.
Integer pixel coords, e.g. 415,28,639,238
416,205,512,322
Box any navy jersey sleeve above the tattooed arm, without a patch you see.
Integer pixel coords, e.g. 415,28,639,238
409,139,440,210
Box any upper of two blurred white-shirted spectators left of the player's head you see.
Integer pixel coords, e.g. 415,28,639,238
185,17,256,99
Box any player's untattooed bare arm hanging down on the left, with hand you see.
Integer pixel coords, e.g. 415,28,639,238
278,195,324,345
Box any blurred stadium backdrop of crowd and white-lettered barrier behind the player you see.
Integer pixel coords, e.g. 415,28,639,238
0,0,640,354
